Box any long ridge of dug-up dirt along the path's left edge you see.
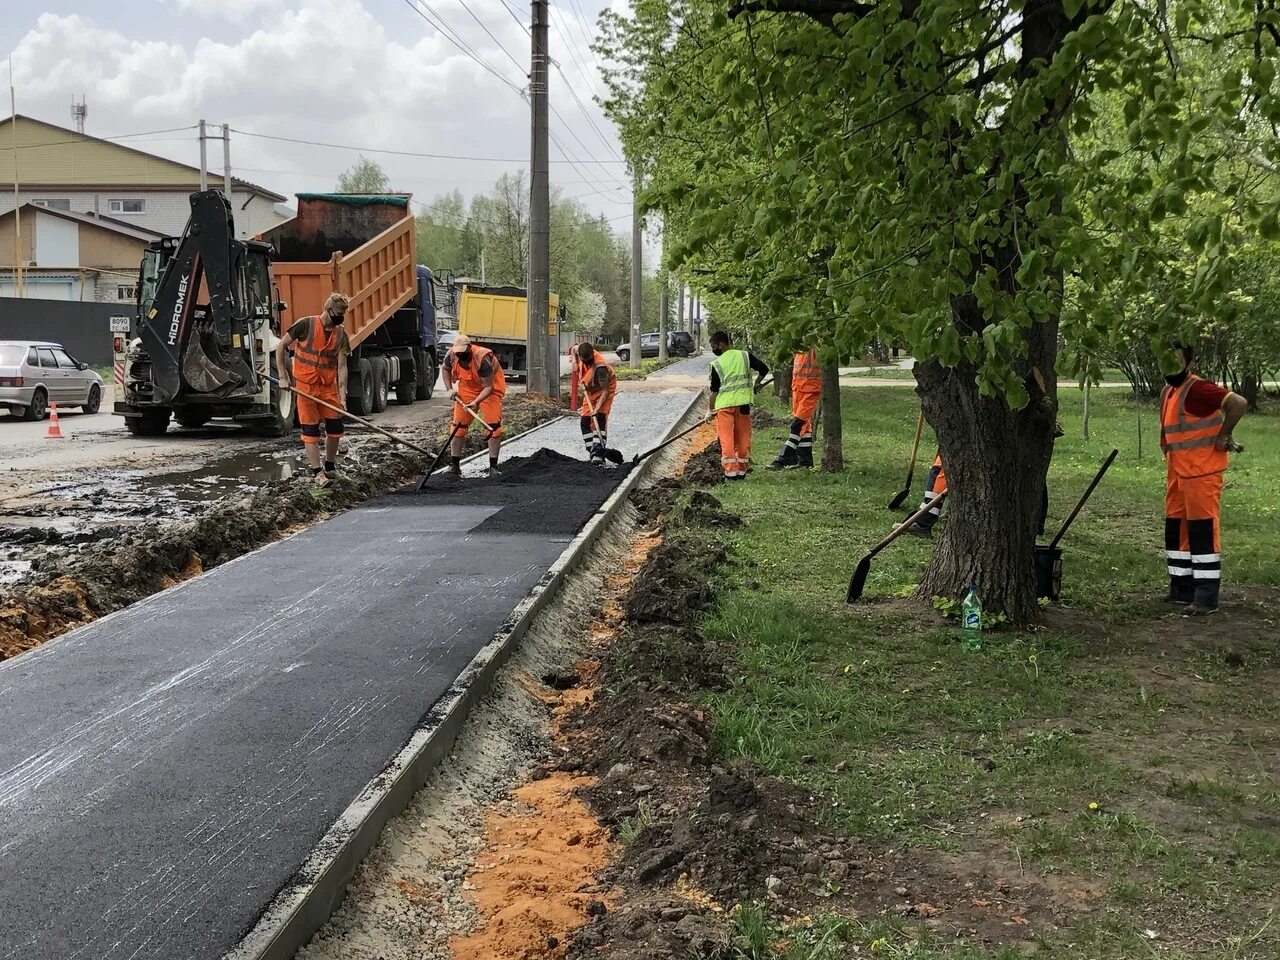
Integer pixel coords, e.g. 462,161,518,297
0,396,565,659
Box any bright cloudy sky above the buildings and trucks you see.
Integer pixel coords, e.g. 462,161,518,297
0,0,630,229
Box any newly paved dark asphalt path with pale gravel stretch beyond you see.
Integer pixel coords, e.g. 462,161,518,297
0,378,705,960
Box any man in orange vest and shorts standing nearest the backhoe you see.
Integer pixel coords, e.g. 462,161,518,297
275,293,351,486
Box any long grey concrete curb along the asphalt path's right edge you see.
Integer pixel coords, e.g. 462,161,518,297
224,393,701,960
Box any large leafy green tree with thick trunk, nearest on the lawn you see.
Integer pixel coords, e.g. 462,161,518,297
604,0,1280,622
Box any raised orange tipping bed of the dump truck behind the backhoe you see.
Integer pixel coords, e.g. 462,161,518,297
261,193,417,348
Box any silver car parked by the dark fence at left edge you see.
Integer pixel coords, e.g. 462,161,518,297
0,340,102,420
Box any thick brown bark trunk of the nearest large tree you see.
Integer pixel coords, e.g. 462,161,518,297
915,300,1057,623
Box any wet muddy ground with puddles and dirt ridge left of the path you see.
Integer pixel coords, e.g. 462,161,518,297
0,394,564,659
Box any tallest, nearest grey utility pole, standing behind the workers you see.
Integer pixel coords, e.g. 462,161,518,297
526,0,559,397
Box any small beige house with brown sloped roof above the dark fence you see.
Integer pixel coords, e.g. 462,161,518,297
0,204,163,302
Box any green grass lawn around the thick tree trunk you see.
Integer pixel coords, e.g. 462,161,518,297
675,387,1280,960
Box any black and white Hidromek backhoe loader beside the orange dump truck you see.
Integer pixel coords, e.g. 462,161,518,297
113,189,293,436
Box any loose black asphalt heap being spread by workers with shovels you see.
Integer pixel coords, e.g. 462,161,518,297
384,448,630,535
